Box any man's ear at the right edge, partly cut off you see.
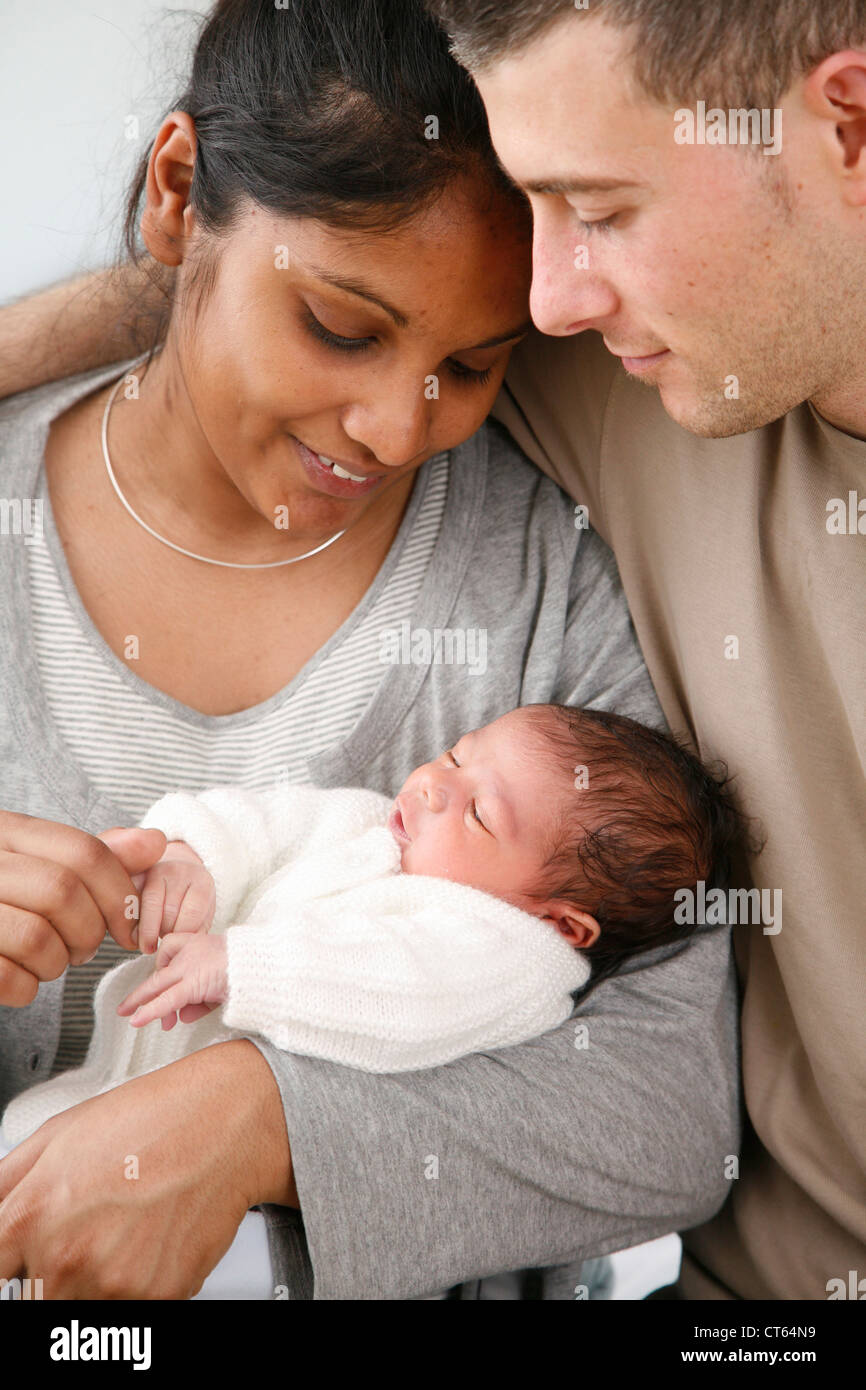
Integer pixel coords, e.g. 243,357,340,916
803,49,866,207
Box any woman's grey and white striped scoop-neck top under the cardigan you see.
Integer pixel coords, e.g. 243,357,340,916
28,453,449,1074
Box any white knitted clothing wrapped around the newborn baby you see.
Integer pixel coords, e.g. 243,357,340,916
3,785,589,1144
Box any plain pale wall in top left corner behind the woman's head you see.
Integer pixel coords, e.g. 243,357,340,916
0,0,210,302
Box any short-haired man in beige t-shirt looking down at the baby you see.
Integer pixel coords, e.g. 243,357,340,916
432,0,866,1298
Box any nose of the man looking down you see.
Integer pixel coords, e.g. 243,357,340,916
530,204,619,338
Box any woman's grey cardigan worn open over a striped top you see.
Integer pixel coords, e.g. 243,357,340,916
0,366,740,1298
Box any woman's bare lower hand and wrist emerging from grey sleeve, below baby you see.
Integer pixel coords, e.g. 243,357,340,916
0,1040,297,1300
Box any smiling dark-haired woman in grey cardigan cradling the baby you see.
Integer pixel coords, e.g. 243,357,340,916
0,0,737,1297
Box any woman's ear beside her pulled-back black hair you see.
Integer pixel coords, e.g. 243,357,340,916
142,111,197,265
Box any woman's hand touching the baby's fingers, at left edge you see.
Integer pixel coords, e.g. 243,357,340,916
0,810,165,1008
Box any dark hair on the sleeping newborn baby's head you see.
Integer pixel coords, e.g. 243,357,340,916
524,705,760,983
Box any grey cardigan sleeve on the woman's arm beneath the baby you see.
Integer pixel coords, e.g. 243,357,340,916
250,927,740,1300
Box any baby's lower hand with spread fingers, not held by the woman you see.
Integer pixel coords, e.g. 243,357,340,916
117,935,228,1031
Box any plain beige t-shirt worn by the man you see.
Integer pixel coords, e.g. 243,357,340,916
495,332,866,1298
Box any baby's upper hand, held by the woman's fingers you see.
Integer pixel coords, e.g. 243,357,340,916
132,841,217,955
